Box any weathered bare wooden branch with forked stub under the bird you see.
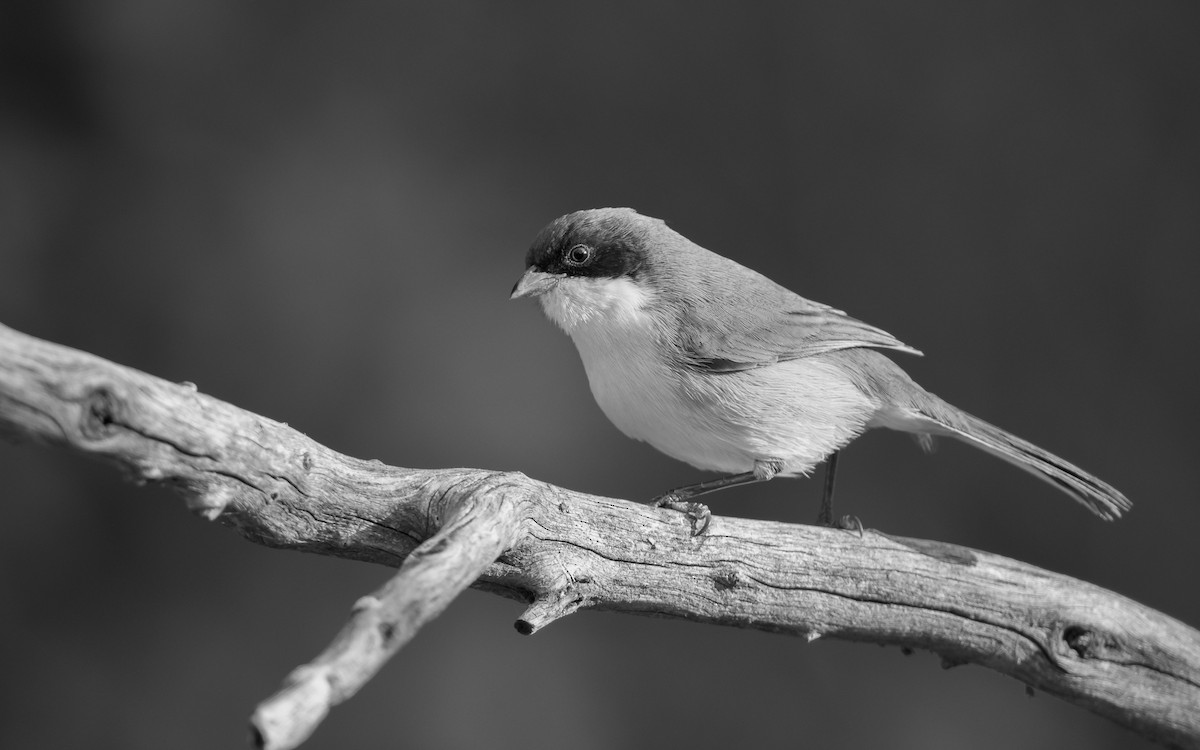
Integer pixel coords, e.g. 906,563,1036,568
0,325,1200,749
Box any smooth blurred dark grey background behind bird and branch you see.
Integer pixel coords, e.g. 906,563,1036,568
0,0,1200,749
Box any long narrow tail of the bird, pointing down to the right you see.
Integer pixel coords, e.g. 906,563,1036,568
902,391,1133,521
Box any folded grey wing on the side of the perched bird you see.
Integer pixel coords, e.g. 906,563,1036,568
682,277,920,372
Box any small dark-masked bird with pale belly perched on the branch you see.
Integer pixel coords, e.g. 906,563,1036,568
511,209,1130,534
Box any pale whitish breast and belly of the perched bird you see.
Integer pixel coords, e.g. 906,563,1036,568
575,326,872,474
